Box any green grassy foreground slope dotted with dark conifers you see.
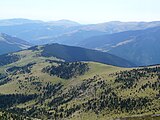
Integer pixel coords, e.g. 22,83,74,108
0,50,160,120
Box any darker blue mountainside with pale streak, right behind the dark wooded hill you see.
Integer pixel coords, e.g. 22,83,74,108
80,27,160,66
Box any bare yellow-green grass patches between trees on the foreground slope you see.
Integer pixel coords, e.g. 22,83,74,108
0,50,160,120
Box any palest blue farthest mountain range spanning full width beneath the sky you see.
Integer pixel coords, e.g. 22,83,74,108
0,19,160,45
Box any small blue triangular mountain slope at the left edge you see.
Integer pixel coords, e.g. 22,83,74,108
0,33,32,55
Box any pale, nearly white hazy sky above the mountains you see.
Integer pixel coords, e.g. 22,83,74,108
0,0,160,23
